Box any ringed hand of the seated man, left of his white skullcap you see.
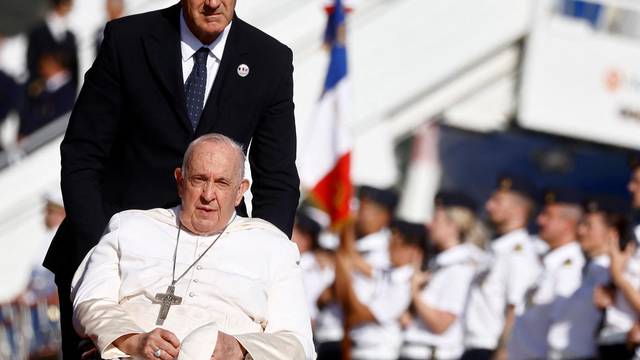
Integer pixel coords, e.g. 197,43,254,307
113,328,180,360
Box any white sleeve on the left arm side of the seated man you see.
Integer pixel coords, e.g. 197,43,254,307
71,214,144,359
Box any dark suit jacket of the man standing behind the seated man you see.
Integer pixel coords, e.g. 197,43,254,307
44,4,300,279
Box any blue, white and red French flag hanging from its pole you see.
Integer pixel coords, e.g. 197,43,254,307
300,0,353,228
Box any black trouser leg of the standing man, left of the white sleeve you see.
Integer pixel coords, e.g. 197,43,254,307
56,276,82,360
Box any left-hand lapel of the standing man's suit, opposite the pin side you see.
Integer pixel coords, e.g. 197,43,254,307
143,4,193,132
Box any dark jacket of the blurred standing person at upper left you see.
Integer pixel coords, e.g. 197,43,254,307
27,22,79,89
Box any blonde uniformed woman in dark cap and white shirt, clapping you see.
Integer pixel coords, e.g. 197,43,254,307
400,192,484,359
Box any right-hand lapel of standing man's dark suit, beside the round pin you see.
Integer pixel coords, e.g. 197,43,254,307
196,15,249,137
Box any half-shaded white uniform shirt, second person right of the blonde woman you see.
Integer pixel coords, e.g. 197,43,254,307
507,241,585,360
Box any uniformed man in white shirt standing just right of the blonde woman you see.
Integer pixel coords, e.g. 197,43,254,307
462,174,541,360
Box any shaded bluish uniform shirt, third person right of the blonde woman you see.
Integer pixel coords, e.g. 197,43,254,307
547,255,610,359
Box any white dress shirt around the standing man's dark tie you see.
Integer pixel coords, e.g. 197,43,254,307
180,10,232,107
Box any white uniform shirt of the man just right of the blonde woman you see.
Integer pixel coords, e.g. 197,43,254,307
464,229,542,350
